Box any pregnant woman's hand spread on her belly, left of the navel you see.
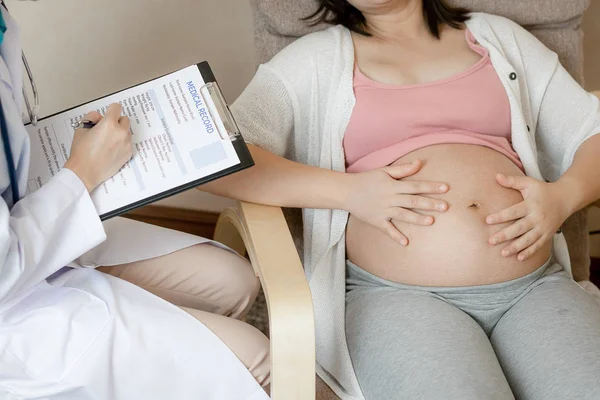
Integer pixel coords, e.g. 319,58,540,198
345,161,448,246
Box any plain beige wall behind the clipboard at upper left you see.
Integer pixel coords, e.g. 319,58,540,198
7,0,255,211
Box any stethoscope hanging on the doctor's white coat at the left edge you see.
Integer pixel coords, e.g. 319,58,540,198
0,0,40,205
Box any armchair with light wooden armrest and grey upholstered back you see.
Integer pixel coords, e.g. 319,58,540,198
215,0,590,400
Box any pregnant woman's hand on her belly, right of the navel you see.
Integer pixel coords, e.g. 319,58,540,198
486,174,569,261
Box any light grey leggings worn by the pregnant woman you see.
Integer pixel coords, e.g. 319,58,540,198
346,262,600,400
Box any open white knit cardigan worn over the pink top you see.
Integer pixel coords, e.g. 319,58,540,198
232,13,600,399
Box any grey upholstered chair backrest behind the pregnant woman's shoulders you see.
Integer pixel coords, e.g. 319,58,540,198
250,0,590,279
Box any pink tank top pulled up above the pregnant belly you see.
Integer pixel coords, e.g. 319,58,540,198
343,30,523,172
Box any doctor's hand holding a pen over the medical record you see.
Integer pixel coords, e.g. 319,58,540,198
65,104,133,192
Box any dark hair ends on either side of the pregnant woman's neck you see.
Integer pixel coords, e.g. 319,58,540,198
304,0,469,39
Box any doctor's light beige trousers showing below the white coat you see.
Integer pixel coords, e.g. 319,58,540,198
98,243,270,388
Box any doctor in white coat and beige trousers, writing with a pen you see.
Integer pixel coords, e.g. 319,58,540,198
0,3,269,400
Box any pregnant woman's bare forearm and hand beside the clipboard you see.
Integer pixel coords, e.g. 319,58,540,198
200,145,448,245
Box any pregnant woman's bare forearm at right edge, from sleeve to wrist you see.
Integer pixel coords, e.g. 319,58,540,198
557,135,600,215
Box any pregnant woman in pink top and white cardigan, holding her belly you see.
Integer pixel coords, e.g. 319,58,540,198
205,0,600,400
